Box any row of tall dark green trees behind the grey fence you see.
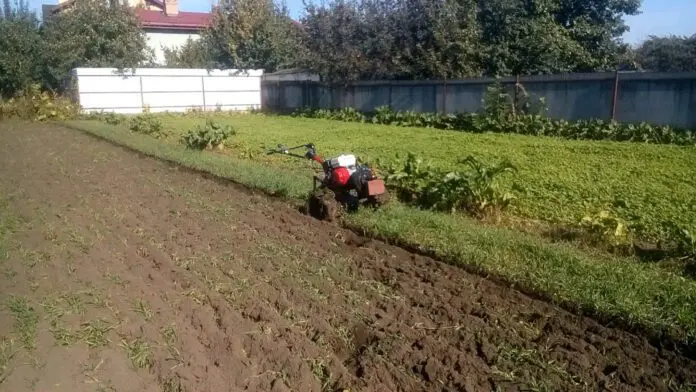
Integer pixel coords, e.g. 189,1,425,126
302,0,639,81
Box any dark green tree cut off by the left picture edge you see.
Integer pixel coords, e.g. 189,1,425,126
0,0,43,97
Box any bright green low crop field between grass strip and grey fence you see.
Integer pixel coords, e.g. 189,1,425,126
152,115,696,239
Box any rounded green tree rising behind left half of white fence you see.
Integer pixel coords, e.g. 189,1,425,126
44,0,152,88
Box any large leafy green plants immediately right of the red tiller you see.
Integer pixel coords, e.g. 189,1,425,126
385,154,515,218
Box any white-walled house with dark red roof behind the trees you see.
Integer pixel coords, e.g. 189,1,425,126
43,0,213,64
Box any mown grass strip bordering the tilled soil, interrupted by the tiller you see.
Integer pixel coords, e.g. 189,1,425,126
62,121,696,348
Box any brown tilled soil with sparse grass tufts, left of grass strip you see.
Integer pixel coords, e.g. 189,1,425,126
0,125,696,392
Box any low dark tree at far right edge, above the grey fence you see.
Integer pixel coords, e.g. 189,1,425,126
636,34,696,72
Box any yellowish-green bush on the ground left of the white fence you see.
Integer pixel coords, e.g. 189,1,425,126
0,84,79,121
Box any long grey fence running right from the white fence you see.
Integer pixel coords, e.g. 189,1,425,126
261,72,696,128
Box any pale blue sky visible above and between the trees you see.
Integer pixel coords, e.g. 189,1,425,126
29,0,696,44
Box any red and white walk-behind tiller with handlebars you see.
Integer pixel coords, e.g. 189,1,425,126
268,143,388,221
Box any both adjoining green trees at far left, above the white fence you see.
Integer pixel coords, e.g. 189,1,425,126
0,0,152,98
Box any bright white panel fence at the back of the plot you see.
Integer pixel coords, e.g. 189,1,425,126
70,68,263,113
